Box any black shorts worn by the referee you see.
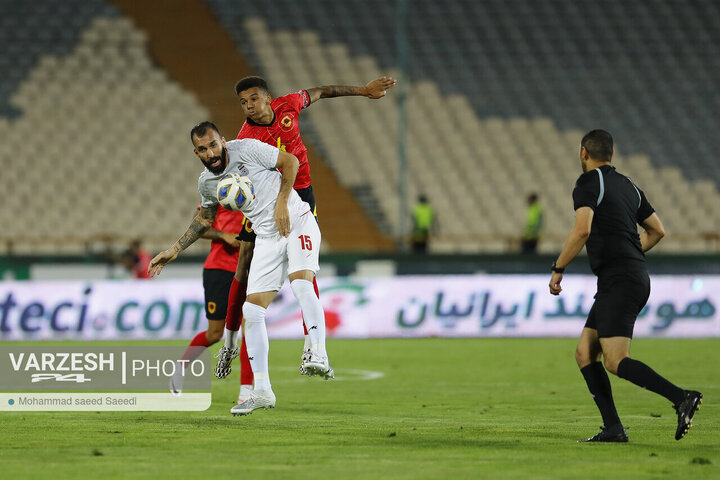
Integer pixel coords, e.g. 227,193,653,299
585,270,650,338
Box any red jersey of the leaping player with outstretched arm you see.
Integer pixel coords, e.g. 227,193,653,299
237,90,310,190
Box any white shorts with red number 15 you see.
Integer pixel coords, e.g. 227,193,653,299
247,212,321,295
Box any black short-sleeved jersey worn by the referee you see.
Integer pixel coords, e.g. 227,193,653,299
573,165,655,275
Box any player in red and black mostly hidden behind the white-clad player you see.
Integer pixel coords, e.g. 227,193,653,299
170,207,254,394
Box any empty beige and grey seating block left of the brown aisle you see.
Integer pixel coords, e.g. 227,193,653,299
0,0,208,255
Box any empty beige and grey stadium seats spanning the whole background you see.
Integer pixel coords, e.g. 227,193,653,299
0,0,720,254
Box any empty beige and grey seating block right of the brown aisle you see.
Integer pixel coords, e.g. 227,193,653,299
208,0,720,252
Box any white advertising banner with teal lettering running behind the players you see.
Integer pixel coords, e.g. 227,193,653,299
0,275,720,341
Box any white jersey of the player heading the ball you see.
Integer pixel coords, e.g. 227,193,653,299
198,138,310,236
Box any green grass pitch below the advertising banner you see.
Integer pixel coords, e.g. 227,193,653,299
0,339,720,480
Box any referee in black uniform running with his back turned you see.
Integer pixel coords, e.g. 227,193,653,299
550,130,702,442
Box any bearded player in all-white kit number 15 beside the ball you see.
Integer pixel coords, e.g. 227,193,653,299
148,122,330,415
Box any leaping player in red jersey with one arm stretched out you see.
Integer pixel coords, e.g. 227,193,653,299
219,77,397,398
